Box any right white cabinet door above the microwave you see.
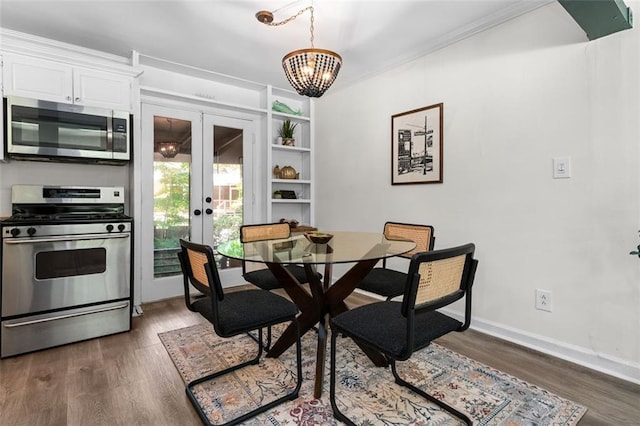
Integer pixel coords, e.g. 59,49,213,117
73,68,131,111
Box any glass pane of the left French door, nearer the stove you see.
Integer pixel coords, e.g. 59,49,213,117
153,116,191,278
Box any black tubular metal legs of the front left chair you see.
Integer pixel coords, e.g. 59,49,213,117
186,319,302,426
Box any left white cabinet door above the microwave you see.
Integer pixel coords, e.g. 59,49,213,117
3,55,73,103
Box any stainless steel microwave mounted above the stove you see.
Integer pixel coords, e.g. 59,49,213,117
5,97,131,164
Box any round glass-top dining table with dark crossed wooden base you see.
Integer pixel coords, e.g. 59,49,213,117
217,231,416,398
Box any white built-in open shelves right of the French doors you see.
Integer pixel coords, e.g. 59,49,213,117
267,89,315,226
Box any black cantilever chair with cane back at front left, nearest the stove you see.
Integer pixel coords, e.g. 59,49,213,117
178,240,302,425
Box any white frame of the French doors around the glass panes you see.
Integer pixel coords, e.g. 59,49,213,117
137,99,261,306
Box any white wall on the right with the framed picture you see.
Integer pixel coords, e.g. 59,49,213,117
316,2,640,382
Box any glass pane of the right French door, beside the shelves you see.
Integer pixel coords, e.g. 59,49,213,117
212,126,243,269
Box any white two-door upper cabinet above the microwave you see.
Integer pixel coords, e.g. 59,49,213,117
3,55,132,111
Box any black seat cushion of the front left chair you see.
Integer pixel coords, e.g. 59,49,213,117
193,290,298,337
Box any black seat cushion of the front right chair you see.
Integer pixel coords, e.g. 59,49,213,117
331,302,462,360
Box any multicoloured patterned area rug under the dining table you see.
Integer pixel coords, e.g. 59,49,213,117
158,324,586,426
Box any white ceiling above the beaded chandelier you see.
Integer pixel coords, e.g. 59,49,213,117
0,0,554,93
